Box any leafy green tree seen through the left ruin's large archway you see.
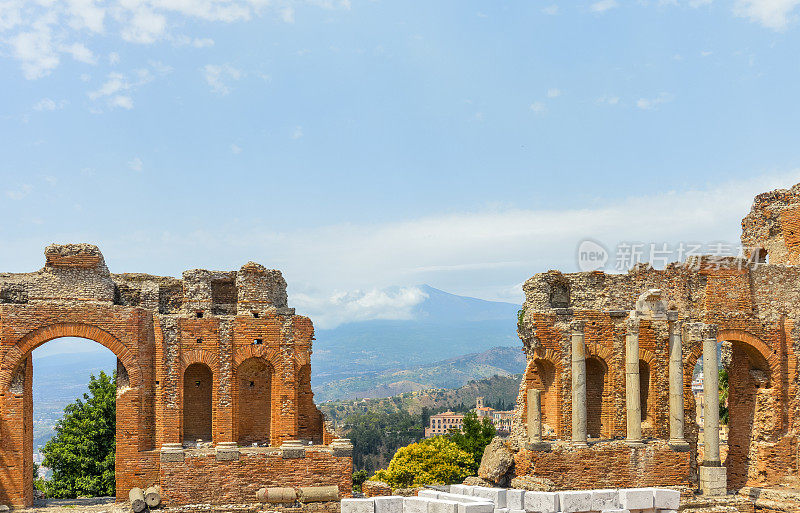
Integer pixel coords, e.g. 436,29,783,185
42,372,117,499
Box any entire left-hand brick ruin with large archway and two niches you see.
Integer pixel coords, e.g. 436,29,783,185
0,244,352,506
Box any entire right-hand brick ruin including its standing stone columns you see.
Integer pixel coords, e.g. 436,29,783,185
512,184,800,495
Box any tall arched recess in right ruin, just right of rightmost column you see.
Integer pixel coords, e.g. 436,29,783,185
720,341,781,489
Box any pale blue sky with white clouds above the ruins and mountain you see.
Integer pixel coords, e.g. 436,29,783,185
0,0,800,332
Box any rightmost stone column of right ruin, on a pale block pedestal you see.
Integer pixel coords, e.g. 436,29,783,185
700,330,728,495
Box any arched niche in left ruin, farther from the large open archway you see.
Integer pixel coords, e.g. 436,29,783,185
236,358,273,445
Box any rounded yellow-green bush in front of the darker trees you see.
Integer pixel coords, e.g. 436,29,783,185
372,436,473,488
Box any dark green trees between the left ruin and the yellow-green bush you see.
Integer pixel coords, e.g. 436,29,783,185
343,411,424,472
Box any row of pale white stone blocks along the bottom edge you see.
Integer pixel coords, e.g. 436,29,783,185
341,485,681,513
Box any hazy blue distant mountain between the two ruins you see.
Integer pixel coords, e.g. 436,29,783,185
311,285,520,392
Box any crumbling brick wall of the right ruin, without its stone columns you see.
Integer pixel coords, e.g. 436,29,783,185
511,184,800,489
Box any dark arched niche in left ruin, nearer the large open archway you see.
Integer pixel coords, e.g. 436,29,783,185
183,363,214,442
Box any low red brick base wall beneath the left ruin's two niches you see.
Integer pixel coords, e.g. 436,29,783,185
160,449,353,505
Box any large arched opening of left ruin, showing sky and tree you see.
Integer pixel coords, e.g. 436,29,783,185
30,337,118,498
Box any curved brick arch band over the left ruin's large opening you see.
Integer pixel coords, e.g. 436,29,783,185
0,322,142,389
